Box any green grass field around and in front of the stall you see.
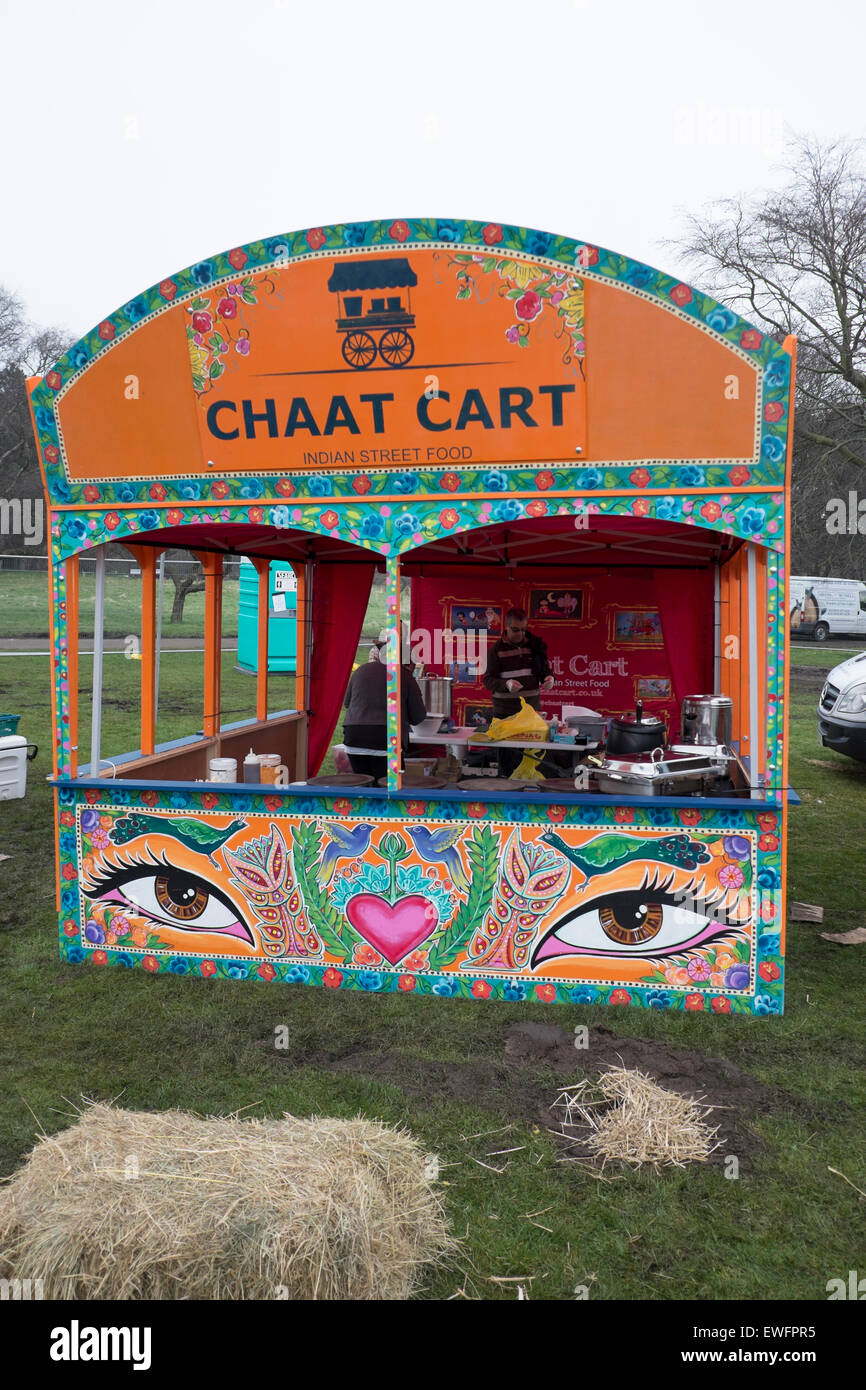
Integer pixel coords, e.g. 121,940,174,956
0,653,866,1301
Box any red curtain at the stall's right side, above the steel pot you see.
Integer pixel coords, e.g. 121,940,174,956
652,566,713,711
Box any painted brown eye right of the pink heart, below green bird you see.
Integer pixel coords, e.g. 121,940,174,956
532,887,740,965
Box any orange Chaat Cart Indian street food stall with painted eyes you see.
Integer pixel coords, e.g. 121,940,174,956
31,220,795,1015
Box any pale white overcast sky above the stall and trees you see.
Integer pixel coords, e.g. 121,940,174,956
0,0,866,334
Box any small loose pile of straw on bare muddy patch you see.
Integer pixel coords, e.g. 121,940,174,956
552,1066,720,1168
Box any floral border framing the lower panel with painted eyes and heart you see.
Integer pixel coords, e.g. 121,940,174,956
57,783,784,1015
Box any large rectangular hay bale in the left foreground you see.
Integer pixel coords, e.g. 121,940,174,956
0,1104,455,1300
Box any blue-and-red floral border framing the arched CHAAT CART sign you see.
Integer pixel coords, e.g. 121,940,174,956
33,218,791,506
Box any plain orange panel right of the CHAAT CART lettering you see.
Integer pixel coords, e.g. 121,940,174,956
585,281,758,460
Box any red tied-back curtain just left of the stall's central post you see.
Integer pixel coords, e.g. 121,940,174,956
307,563,375,777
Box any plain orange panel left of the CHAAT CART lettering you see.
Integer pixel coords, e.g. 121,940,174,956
57,306,202,481
